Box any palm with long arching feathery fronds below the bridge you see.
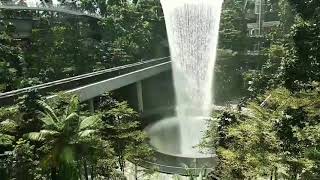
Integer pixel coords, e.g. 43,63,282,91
25,96,101,180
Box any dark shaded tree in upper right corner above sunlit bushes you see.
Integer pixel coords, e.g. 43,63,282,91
284,0,320,90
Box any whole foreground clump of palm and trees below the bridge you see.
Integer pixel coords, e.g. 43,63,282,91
0,92,152,180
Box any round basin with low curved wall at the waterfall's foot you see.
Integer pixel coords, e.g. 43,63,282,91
145,117,216,175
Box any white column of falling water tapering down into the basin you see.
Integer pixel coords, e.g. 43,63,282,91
161,0,223,156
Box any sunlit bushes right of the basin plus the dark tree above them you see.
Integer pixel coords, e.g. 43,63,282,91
203,0,320,180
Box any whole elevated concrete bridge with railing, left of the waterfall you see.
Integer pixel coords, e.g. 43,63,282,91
0,57,171,106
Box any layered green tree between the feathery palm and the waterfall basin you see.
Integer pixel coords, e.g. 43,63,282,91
102,94,152,172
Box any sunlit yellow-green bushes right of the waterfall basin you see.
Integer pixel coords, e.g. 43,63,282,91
205,86,320,179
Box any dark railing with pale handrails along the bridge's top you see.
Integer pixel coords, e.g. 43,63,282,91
0,57,170,106
